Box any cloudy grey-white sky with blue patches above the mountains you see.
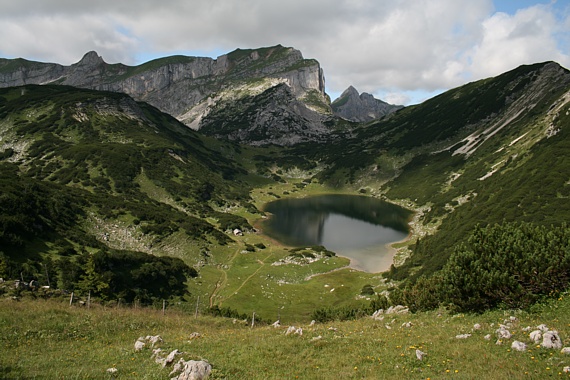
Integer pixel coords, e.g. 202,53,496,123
0,0,570,105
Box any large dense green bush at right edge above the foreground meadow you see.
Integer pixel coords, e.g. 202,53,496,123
398,223,570,312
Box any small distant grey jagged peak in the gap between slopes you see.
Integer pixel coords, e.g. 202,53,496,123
332,86,403,122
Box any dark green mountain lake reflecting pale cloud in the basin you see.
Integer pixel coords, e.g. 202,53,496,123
262,194,411,273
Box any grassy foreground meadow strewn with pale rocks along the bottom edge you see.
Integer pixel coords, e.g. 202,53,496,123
0,296,570,379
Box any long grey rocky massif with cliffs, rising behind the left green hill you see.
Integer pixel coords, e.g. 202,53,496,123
0,45,332,145
